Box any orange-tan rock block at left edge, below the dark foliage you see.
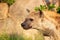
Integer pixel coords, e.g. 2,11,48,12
0,3,8,19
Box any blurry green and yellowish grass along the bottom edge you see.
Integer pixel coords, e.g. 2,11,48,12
0,33,43,40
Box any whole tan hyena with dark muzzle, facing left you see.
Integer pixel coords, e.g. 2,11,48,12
21,10,60,40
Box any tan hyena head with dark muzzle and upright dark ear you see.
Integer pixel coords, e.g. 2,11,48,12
21,10,43,29
